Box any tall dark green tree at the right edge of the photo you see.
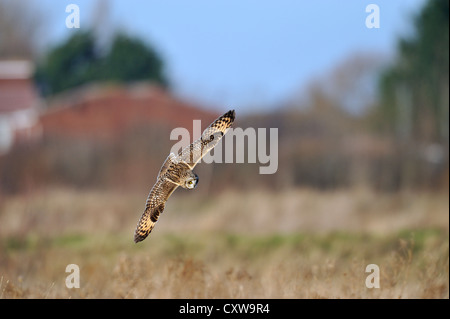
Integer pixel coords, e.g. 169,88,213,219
380,0,449,143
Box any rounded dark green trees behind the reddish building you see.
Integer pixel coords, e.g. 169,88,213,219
35,31,168,95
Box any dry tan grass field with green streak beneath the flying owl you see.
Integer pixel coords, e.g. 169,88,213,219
0,189,449,298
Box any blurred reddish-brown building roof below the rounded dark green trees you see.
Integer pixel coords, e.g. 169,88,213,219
41,82,218,140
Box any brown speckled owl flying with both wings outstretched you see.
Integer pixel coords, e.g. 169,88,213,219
134,110,235,243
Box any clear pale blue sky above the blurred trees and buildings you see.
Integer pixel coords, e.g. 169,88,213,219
39,0,426,112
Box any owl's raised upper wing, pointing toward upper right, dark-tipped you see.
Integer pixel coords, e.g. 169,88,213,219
177,110,235,169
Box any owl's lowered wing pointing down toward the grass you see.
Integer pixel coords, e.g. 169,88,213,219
134,175,178,243
